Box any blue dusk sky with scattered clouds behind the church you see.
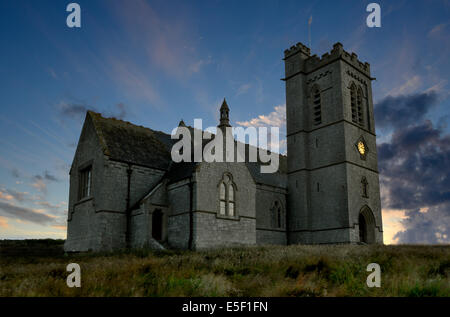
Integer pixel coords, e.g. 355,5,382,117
0,0,450,244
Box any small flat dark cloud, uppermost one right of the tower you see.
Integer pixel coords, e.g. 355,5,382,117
374,91,438,128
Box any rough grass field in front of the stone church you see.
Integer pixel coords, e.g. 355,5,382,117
0,240,450,297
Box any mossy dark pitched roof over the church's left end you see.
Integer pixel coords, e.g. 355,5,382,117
87,111,173,170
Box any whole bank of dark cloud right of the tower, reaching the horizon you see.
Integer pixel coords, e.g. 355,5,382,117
376,93,450,243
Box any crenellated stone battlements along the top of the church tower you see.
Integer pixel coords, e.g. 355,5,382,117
284,42,370,77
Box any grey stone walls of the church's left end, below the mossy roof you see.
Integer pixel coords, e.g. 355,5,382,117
65,115,164,251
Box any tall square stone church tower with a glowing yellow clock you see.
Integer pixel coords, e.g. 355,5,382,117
283,43,383,244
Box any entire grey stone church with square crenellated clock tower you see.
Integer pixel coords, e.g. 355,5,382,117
65,43,383,252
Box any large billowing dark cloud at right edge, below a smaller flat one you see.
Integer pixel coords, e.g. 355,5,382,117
378,121,450,209
